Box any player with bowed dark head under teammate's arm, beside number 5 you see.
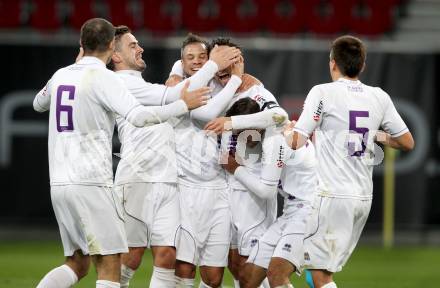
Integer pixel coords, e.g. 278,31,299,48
223,98,317,287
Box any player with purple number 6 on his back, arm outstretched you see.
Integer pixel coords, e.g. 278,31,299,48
34,18,210,288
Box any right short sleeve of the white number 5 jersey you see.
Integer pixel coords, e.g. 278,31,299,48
378,88,409,138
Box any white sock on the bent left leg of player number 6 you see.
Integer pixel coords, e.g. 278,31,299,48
37,264,78,288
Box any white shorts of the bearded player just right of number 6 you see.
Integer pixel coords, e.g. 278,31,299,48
114,183,180,248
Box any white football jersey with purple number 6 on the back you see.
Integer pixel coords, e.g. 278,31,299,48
34,57,140,186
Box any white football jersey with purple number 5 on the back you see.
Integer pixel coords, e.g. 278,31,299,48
294,78,408,199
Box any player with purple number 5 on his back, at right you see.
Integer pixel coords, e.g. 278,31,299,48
286,36,414,288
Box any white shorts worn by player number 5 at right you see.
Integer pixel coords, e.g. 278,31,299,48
304,196,371,272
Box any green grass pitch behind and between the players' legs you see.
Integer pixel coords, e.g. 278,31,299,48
0,241,440,288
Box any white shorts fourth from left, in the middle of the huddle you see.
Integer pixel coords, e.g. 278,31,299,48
230,189,277,256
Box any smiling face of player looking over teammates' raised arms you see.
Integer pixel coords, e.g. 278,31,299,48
182,42,208,76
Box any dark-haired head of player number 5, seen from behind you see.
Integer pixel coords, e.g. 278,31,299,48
330,35,367,77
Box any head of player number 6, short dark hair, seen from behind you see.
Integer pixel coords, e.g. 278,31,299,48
80,18,115,53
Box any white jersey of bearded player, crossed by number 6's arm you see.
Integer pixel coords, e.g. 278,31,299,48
115,70,177,185
